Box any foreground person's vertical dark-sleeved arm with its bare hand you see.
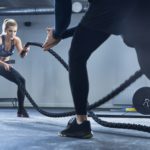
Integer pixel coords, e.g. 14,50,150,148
43,0,72,50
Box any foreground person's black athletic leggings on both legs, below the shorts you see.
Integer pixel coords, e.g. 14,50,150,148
69,26,150,115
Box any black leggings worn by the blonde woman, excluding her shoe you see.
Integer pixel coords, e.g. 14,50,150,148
0,65,25,109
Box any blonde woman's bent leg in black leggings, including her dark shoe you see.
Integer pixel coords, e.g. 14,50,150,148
0,66,29,117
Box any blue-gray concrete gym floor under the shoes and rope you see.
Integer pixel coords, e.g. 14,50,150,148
0,108,150,150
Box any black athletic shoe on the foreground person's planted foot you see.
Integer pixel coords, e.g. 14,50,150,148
59,118,93,139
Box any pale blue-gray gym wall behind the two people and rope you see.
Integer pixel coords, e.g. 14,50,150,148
0,14,150,107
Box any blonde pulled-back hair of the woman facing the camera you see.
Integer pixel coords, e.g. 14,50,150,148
2,18,18,34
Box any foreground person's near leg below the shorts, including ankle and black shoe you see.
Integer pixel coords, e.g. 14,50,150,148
60,26,109,138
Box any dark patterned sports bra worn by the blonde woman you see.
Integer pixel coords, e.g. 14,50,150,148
0,35,15,57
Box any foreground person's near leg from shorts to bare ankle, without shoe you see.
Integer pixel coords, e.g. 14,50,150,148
69,26,109,123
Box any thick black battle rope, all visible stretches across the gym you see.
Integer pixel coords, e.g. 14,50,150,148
15,42,150,132
